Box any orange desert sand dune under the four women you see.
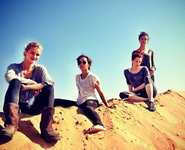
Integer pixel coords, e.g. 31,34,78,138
0,90,185,150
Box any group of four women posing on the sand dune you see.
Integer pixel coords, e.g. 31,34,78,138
0,32,157,143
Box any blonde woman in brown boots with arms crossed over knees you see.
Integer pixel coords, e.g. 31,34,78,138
0,42,60,143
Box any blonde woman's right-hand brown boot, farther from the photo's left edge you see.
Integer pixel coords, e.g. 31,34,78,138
40,107,60,143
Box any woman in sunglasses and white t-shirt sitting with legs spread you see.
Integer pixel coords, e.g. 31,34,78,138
54,55,112,133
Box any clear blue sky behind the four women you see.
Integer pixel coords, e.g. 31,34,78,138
0,0,185,111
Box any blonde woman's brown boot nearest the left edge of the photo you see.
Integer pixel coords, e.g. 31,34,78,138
0,103,19,141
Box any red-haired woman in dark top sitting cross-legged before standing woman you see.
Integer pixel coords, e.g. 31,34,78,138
119,53,157,111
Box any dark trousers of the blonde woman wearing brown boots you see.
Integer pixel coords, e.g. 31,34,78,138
4,79,54,115
